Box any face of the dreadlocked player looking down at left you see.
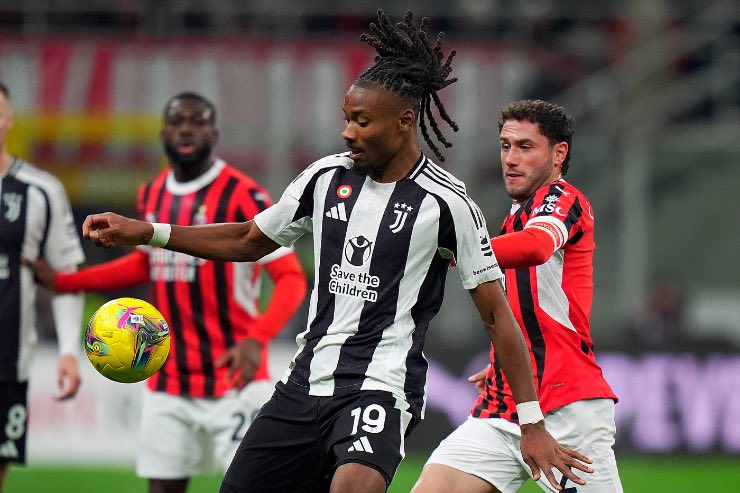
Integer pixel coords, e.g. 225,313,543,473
342,85,407,177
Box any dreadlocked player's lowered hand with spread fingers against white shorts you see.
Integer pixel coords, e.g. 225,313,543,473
520,421,593,490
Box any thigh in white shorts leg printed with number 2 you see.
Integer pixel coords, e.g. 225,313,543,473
211,380,275,471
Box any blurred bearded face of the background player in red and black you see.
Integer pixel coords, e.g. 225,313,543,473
160,99,218,168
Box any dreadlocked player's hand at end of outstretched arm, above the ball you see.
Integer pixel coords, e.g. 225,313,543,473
82,212,154,248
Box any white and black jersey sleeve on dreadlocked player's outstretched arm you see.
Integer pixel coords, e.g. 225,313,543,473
254,163,321,247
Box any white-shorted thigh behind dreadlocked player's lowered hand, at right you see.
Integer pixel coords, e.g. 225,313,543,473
538,399,623,493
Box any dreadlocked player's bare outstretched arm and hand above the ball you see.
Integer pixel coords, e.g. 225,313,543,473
82,212,280,262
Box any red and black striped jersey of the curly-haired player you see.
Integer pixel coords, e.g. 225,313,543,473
471,180,616,421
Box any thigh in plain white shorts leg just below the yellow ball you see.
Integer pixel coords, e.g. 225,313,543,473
136,389,209,479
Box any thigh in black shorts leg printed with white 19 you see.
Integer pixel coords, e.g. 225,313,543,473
320,390,416,484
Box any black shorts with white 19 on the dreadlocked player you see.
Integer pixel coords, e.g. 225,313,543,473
220,383,417,493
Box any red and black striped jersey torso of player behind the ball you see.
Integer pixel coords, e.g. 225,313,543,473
137,160,290,397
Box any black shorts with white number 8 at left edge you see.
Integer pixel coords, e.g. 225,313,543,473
0,382,28,464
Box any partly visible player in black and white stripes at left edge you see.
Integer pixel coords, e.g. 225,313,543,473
0,83,85,491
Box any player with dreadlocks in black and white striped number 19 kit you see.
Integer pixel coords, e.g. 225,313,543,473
78,11,590,493
